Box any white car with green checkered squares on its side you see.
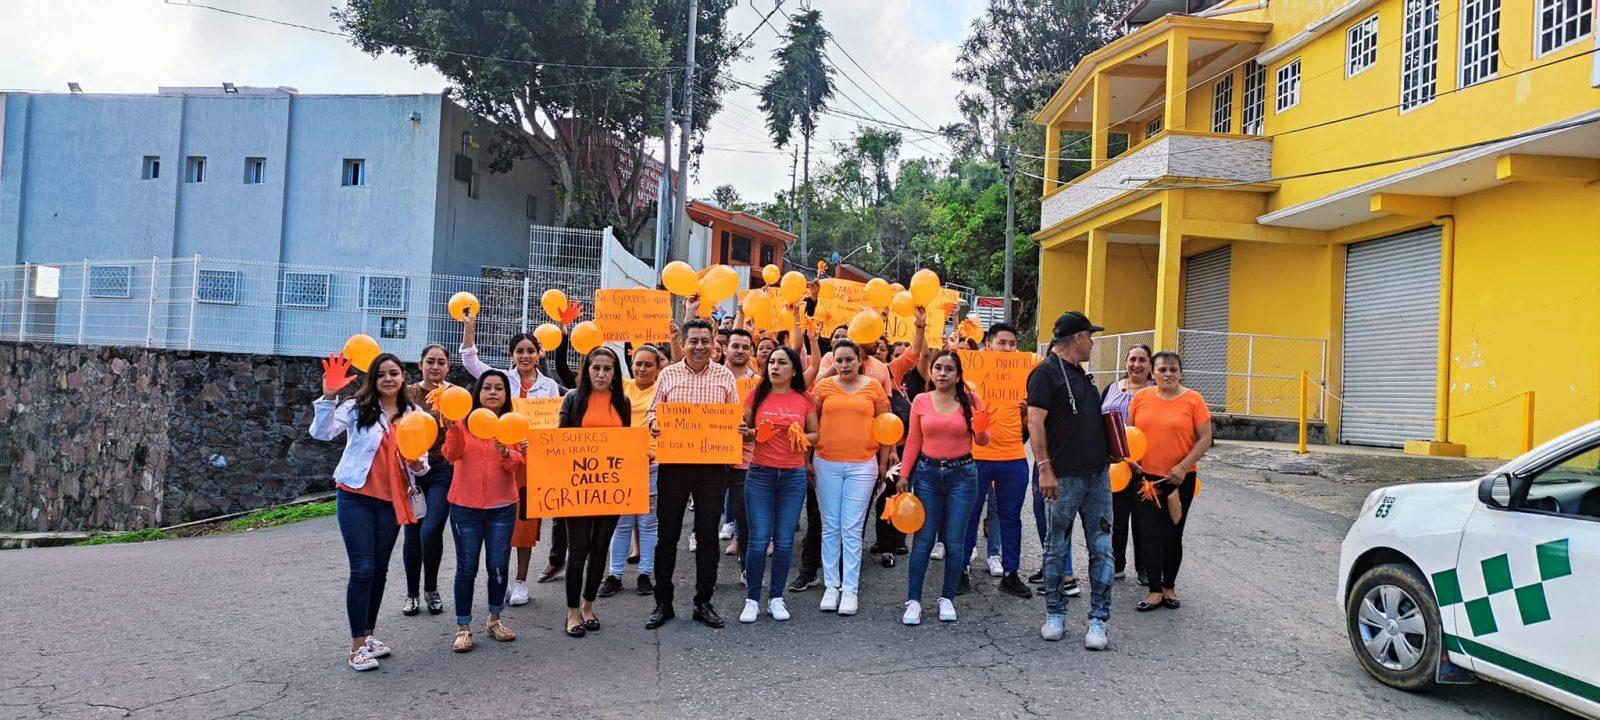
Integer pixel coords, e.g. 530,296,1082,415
1339,422,1600,717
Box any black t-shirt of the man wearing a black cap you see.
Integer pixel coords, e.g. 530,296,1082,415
1027,352,1107,477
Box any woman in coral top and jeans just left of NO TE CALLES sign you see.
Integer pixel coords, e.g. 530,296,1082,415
443,370,523,653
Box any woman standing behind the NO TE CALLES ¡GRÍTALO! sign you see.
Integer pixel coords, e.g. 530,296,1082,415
560,346,634,637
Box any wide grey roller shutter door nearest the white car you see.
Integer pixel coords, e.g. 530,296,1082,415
1339,227,1440,448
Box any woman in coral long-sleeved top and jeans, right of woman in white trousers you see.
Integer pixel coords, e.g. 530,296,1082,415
899,349,989,626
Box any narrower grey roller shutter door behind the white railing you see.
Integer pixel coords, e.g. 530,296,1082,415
1179,246,1234,404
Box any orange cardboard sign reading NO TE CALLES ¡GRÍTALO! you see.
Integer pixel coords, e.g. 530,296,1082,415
520,427,650,520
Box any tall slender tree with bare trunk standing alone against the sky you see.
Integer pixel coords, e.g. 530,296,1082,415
760,10,834,266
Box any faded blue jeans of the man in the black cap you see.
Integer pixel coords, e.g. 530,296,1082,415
1045,469,1115,621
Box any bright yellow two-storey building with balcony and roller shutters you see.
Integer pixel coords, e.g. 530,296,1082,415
1034,0,1600,458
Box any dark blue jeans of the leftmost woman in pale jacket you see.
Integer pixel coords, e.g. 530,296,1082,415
336,488,400,637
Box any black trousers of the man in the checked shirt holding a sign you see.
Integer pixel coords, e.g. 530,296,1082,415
656,466,729,605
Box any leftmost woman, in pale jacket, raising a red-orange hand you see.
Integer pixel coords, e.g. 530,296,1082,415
310,352,429,670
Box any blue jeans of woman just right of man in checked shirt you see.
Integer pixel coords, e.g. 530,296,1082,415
742,464,806,602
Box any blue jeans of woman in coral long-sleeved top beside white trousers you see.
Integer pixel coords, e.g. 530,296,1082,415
906,458,979,602
